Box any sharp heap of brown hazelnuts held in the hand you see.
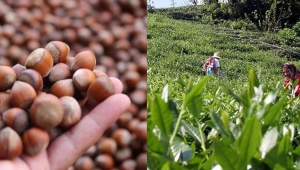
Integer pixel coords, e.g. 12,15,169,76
0,41,114,159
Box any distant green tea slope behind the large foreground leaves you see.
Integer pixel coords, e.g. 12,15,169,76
147,13,300,97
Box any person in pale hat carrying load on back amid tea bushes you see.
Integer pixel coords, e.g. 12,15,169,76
203,52,221,75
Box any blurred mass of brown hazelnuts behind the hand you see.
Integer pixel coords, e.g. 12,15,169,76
0,0,147,170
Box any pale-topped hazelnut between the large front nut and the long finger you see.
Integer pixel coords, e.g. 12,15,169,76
59,96,81,128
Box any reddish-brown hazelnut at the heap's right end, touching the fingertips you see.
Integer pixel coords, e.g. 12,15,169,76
87,76,115,105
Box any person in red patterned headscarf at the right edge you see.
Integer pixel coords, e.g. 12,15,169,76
282,62,300,96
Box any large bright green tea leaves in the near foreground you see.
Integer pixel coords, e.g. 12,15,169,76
147,69,300,170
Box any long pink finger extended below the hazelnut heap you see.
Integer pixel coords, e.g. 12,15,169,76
48,94,130,169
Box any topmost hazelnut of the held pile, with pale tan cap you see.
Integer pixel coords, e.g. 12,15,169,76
45,41,70,64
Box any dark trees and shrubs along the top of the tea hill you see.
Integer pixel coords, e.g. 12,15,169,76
157,0,300,32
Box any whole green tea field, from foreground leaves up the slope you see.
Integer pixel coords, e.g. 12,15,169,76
147,13,300,170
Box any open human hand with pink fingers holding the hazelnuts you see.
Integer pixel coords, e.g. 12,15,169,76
0,78,130,170
